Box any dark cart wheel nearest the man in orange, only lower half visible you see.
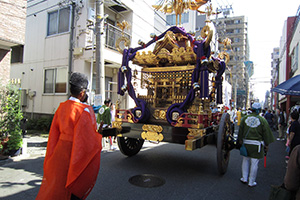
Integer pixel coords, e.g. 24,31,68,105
118,137,144,156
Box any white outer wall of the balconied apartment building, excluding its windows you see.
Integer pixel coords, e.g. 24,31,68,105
11,0,158,114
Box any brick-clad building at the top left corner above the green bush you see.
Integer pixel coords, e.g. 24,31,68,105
0,0,27,85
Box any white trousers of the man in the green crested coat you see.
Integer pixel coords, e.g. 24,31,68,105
242,156,259,185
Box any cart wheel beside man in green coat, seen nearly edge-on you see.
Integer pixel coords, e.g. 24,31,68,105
217,113,232,175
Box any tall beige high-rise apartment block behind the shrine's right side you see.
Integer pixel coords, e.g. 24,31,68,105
212,16,253,108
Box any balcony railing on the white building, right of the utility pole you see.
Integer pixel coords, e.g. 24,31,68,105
105,24,131,51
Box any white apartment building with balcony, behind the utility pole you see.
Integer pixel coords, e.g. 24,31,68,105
10,0,159,116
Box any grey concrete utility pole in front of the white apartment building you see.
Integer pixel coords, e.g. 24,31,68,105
95,0,105,104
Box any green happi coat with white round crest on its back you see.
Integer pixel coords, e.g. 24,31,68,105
238,112,275,159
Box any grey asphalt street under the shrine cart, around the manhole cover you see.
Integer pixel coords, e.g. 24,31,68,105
0,130,286,200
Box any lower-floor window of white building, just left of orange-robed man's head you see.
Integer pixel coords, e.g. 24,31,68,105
44,67,68,94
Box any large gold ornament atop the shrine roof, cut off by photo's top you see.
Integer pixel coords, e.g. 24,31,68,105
152,0,208,26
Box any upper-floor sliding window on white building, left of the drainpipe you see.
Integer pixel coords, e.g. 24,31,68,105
47,7,70,36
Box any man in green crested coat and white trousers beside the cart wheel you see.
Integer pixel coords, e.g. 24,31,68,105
238,102,275,187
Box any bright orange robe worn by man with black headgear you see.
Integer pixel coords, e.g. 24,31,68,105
36,100,102,200
